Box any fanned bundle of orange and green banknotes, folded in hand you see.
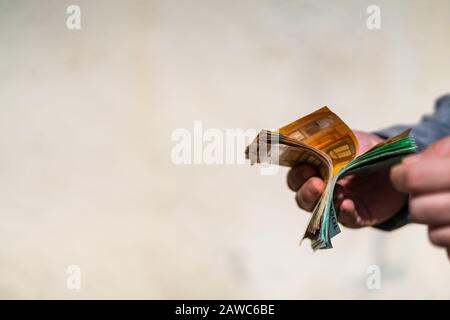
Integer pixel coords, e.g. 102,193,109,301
245,107,417,250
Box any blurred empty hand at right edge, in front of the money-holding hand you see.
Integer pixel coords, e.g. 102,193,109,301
391,137,450,258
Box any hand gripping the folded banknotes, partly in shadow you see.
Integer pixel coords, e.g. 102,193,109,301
288,131,407,228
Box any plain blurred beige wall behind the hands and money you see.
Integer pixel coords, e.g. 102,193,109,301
0,0,450,299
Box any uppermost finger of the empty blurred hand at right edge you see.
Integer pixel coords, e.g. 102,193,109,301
390,156,450,193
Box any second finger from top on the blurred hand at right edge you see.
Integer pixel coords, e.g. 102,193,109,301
409,192,450,225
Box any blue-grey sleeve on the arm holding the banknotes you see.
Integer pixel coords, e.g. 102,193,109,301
374,94,450,231
